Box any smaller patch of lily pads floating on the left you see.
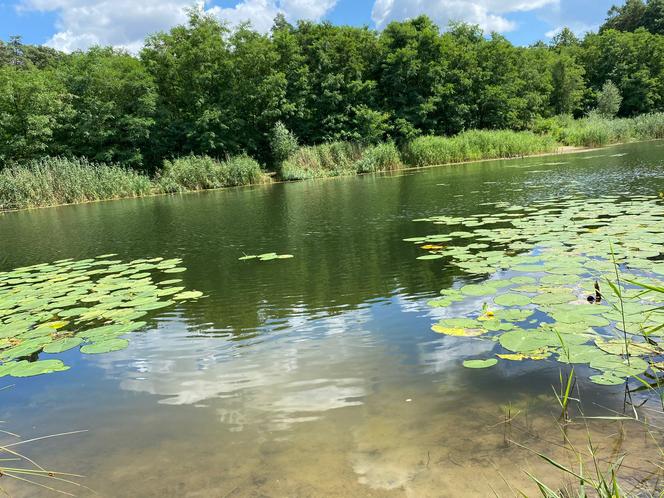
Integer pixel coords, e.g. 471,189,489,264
0,254,203,377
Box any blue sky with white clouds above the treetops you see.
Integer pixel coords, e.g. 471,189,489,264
0,0,622,52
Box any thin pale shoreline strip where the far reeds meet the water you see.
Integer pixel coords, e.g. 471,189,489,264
0,139,644,215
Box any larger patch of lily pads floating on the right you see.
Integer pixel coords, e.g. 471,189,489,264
405,196,664,385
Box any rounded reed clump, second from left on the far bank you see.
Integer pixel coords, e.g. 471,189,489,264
156,155,265,192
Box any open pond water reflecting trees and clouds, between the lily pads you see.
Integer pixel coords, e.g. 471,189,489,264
0,142,664,496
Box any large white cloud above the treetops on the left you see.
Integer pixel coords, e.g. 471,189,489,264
18,0,337,52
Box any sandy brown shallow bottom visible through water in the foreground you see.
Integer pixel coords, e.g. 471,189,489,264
3,380,662,497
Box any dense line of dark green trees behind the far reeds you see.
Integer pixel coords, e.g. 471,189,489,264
0,0,664,169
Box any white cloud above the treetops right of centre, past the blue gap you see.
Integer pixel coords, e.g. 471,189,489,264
371,0,560,32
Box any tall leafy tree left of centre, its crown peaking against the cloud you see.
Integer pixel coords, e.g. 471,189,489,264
140,9,236,165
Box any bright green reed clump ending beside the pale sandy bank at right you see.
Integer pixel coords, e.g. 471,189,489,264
403,130,558,166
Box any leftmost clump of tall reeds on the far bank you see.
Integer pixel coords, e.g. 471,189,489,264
0,157,153,210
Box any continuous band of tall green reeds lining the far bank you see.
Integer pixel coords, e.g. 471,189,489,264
0,113,664,211
